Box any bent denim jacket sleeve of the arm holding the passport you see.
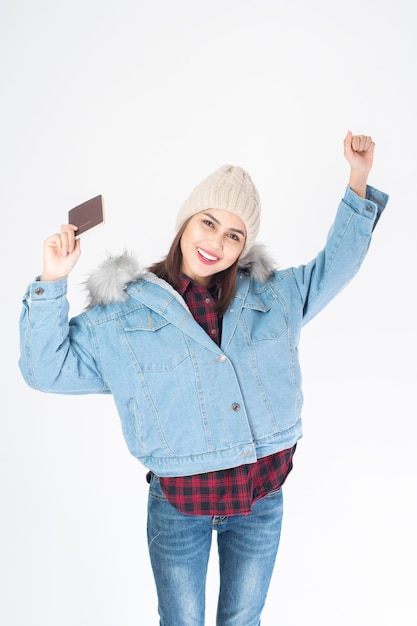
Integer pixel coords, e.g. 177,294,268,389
19,279,108,394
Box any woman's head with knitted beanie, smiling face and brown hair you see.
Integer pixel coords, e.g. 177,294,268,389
149,165,261,315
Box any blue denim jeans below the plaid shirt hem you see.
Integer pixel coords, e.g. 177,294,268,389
148,475,282,626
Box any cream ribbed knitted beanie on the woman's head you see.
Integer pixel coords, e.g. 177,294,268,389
176,165,261,254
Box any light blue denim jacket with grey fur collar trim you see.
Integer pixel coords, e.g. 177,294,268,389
19,187,388,476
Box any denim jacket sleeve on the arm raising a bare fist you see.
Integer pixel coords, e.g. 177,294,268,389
292,186,388,324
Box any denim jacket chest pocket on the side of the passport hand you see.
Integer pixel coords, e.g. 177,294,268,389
121,309,190,372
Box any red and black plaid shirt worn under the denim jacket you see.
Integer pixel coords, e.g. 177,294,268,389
151,276,296,516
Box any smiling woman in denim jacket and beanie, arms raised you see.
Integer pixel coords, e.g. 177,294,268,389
20,132,388,626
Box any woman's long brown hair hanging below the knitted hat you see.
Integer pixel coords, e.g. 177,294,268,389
148,218,239,315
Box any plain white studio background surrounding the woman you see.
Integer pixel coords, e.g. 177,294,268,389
0,0,417,626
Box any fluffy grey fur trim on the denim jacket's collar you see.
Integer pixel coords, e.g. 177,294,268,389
85,243,276,308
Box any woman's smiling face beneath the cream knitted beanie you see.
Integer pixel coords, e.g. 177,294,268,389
180,209,246,287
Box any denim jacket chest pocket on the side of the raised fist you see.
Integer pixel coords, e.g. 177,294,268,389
242,289,288,342
